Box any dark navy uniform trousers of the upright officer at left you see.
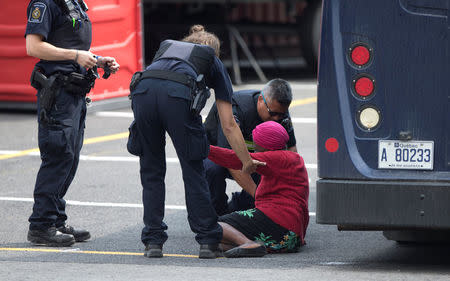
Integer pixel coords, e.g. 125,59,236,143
29,89,86,229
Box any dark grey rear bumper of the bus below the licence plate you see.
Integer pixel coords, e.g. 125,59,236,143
316,179,450,230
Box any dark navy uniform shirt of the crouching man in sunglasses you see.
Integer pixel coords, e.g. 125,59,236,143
205,90,296,152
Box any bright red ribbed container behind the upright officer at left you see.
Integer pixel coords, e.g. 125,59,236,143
0,0,143,103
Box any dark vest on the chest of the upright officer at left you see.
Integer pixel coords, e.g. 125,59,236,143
47,0,92,51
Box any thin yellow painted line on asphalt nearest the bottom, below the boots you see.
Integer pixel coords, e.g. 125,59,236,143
0,248,198,258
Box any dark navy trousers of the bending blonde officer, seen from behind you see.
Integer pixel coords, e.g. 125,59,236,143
132,79,222,244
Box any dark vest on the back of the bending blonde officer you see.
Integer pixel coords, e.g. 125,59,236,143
153,40,215,76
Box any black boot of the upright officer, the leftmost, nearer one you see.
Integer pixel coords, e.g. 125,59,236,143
27,227,75,247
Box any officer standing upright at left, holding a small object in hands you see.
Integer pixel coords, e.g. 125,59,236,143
25,0,119,247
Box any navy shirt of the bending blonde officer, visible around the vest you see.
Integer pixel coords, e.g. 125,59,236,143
147,57,233,103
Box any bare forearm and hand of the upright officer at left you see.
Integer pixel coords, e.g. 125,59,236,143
25,34,97,68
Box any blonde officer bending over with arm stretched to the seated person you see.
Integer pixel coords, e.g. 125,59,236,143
128,25,264,258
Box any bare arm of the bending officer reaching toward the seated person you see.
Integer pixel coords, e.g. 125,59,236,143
216,99,265,174
